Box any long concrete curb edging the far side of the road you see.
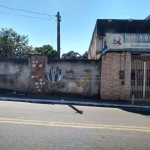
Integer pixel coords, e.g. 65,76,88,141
0,97,150,109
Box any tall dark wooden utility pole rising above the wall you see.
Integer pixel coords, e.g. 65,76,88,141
56,12,61,59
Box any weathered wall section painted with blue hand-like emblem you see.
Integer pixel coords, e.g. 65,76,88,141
44,59,100,96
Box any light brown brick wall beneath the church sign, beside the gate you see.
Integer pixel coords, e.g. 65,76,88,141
100,52,131,100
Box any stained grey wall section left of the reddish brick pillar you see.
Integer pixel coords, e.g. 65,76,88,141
0,59,30,92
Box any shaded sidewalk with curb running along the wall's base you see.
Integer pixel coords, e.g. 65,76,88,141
0,93,150,109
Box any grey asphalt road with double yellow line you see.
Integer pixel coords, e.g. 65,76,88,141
0,101,150,150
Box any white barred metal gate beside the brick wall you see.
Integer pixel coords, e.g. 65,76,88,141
131,58,150,98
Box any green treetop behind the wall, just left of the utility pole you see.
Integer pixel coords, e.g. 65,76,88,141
34,45,57,58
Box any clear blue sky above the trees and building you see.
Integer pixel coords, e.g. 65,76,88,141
0,0,150,55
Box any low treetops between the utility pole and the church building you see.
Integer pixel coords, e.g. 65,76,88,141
62,51,88,59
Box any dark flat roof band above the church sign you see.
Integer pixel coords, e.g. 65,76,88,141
96,19,150,36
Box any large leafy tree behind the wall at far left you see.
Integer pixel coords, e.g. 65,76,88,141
0,28,33,58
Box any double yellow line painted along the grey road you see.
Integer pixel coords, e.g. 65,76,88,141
0,118,150,132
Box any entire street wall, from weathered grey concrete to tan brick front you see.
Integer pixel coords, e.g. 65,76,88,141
0,52,131,100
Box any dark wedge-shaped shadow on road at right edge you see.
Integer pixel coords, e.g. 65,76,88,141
120,108,150,118
